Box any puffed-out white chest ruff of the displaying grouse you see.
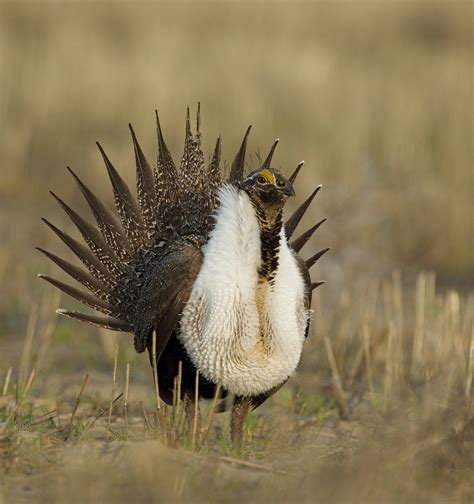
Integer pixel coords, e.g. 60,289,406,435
180,186,309,396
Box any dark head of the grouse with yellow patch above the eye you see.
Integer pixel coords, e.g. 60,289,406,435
239,168,295,209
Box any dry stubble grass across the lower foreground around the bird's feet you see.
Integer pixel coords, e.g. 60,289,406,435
0,272,474,502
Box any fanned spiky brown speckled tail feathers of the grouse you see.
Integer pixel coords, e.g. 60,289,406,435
39,105,329,332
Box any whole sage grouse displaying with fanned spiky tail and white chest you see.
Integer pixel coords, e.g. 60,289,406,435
39,108,328,441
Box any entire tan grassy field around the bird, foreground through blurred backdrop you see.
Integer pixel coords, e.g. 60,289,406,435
0,2,474,503
